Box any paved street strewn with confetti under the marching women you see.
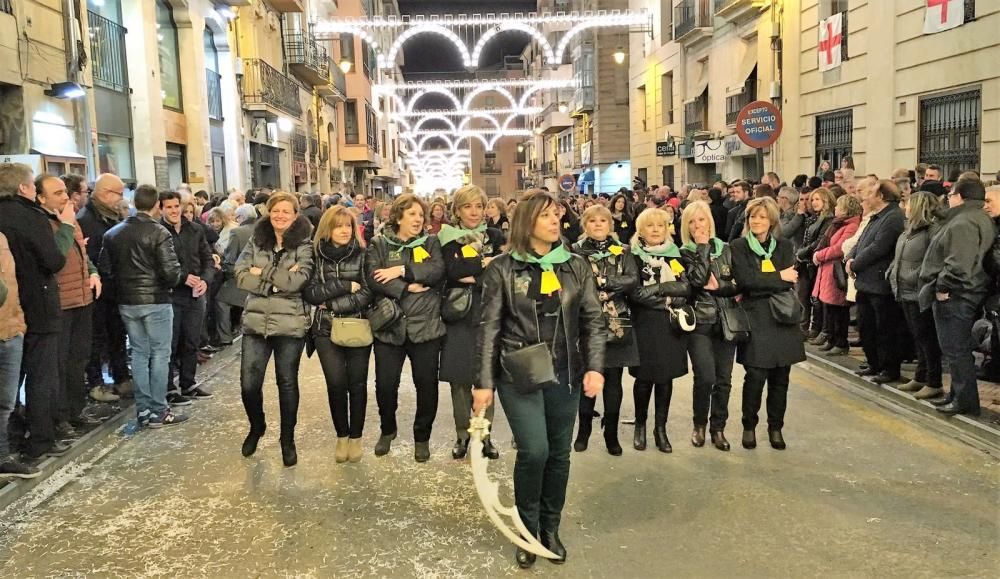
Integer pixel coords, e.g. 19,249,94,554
0,346,1000,577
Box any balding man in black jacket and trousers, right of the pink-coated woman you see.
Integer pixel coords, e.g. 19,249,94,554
847,179,905,384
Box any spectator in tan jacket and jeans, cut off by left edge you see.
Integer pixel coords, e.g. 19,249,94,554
0,233,41,478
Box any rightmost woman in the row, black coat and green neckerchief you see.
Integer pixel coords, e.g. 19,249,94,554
730,197,806,450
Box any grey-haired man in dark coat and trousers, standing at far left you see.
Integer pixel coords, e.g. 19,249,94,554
0,163,76,459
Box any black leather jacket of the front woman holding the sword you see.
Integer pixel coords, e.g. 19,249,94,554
476,254,607,389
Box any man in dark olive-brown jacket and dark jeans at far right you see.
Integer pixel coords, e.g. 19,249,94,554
919,178,996,415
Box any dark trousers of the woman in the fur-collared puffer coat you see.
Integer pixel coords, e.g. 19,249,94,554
240,334,305,441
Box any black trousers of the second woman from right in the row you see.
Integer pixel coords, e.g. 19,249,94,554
688,324,736,432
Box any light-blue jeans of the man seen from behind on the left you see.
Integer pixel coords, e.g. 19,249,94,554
118,304,174,415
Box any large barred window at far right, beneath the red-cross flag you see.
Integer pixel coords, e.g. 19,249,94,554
919,88,982,176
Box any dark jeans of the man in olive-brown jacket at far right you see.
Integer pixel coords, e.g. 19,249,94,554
933,294,979,411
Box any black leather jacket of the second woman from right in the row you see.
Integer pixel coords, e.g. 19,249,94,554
681,243,740,325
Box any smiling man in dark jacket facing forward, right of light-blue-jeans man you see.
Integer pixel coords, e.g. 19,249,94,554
160,191,215,406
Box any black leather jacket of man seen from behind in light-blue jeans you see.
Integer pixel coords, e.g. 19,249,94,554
98,213,184,305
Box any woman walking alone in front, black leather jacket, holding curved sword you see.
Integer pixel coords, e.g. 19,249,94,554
473,190,606,568
